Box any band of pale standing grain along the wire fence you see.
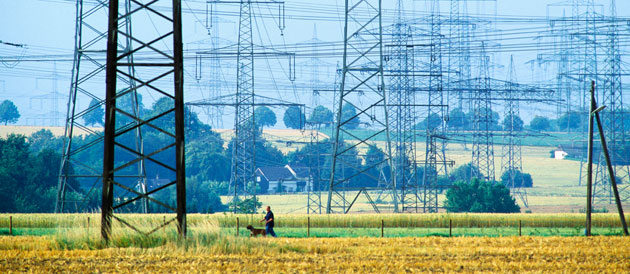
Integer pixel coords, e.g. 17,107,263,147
0,213,630,229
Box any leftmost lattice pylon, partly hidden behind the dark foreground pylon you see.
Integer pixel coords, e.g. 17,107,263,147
55,0,149,213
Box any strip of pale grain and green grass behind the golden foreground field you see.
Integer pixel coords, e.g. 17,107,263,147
0,213,630,238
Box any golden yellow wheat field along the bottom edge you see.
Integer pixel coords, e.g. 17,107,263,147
0,236,630,273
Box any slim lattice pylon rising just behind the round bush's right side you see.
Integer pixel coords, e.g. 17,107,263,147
501,56,528,207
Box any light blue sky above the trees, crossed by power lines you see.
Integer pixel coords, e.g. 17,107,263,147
0,0,630,128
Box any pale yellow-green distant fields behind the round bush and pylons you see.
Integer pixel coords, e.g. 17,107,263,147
253,143,616,213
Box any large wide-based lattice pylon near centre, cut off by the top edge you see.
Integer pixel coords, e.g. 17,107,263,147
326,0,398,213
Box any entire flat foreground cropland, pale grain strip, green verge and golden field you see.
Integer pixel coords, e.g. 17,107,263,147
0,214,630,273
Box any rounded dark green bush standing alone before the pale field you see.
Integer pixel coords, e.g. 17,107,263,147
444,179,521,213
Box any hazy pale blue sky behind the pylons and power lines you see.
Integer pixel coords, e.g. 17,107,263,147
0,0,630,127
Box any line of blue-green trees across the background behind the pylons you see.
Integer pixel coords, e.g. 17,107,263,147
0,97,532,213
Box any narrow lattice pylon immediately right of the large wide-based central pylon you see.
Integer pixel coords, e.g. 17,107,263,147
387,0,422,212
